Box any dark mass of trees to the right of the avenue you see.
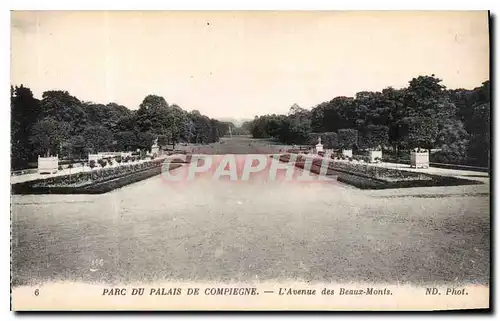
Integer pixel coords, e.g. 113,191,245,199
246,75,490,166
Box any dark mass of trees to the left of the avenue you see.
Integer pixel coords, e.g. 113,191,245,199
11,85,232,169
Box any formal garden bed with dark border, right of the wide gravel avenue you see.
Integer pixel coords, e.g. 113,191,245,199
279,154,482,189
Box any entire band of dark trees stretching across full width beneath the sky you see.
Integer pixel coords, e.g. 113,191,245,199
11,75,491,169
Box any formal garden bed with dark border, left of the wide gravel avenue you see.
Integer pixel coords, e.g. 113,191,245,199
12,159,182,194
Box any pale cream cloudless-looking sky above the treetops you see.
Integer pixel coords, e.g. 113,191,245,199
11,11,489,118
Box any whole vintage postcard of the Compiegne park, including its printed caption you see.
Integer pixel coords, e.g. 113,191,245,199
10,10,492,311
